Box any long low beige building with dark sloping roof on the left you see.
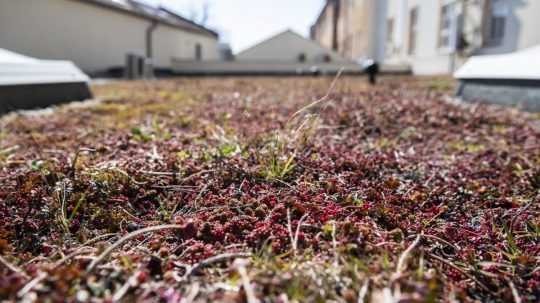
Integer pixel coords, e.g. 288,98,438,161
0,0,219,75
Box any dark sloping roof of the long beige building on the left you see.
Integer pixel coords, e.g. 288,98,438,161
73,0,218,38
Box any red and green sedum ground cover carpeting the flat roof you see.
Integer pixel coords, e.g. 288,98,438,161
0,77,540,302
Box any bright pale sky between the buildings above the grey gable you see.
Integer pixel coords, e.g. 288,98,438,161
144,0,325,53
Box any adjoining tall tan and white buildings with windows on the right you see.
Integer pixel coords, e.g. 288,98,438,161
311,0,540,75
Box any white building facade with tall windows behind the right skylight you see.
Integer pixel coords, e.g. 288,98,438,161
385,0,540,75
